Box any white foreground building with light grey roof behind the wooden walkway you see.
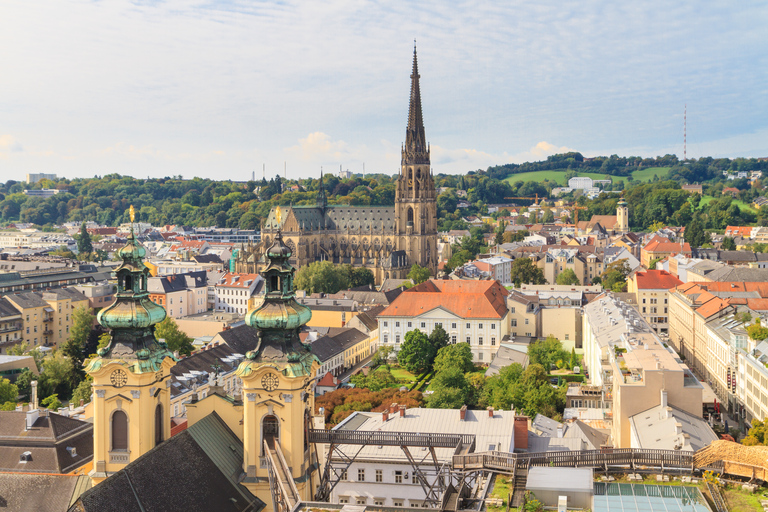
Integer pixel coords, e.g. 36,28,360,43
330,407,516,507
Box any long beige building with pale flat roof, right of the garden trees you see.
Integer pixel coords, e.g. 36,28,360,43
583,293,704,448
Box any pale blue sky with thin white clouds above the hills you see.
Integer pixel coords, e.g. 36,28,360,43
0,0,768,181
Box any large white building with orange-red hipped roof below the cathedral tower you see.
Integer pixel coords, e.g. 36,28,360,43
378,280,510,364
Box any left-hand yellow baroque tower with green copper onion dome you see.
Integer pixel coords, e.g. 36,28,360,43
85,207,176,485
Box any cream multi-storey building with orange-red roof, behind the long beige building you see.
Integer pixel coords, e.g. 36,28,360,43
627,270,683,334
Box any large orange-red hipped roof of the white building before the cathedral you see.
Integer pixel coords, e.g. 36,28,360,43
379,280,509,318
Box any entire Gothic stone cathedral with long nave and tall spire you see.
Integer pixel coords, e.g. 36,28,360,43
235,48,438,283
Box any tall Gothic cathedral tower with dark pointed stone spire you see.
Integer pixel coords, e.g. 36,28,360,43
395,46,438,276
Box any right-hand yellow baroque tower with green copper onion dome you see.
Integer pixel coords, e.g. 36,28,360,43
237,230,320,503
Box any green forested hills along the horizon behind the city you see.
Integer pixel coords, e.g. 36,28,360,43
0,153,768,229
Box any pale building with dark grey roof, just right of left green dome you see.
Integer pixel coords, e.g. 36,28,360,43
147,271,208,318
